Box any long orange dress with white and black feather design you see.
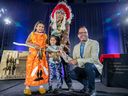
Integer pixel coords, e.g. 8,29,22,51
25,32,48,86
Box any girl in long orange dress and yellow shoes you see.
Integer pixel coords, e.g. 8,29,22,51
24,21,48,95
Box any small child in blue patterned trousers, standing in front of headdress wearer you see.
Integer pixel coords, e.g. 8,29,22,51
47,36,63,92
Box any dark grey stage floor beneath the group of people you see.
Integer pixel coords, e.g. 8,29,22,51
0,80,128,96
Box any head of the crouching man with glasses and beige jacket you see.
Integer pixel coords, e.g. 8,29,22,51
78,27,88,42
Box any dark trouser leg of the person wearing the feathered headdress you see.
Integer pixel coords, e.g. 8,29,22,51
62,59,72,88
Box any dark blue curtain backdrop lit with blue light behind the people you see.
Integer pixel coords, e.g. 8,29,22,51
0,1,126,54
